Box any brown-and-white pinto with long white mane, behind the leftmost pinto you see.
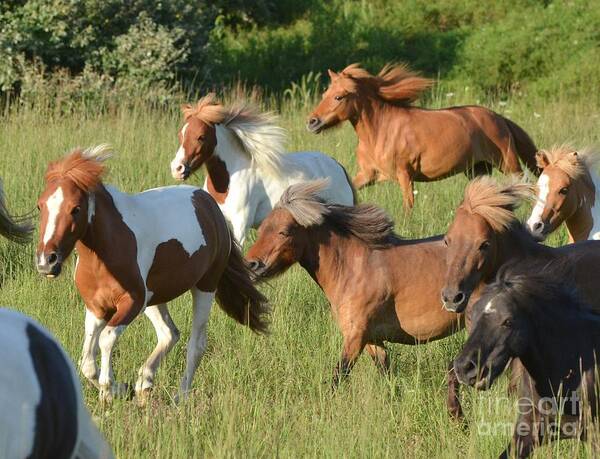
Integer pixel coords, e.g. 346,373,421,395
171,94,355,244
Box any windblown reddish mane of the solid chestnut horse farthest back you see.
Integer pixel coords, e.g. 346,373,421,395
340,64,434,105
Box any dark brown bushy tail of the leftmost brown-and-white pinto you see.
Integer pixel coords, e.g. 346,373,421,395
215,231,270,333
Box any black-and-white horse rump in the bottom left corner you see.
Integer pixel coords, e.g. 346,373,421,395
0,308,113,459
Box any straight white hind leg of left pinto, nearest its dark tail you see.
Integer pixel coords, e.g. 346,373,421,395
176,288,215,400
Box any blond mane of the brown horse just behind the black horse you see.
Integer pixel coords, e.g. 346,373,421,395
460,176,533,232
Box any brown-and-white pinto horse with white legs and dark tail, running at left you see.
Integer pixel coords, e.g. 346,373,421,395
37,145,268,402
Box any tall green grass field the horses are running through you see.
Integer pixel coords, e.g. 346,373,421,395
0,91,600,458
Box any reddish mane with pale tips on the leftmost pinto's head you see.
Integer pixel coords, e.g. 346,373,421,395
45,144,112,192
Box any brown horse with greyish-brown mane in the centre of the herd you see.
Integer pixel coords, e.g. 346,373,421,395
247,180,462,387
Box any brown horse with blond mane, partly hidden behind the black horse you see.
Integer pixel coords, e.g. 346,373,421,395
442,176,600,417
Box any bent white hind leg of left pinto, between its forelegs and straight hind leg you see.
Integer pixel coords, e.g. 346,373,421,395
135,303,179,404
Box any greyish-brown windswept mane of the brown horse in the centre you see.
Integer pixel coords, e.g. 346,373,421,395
276,179,400,249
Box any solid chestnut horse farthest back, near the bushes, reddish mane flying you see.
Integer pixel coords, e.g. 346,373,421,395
307,64,537,208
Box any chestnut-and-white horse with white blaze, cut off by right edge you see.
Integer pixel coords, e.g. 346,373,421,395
527,146,600,242
